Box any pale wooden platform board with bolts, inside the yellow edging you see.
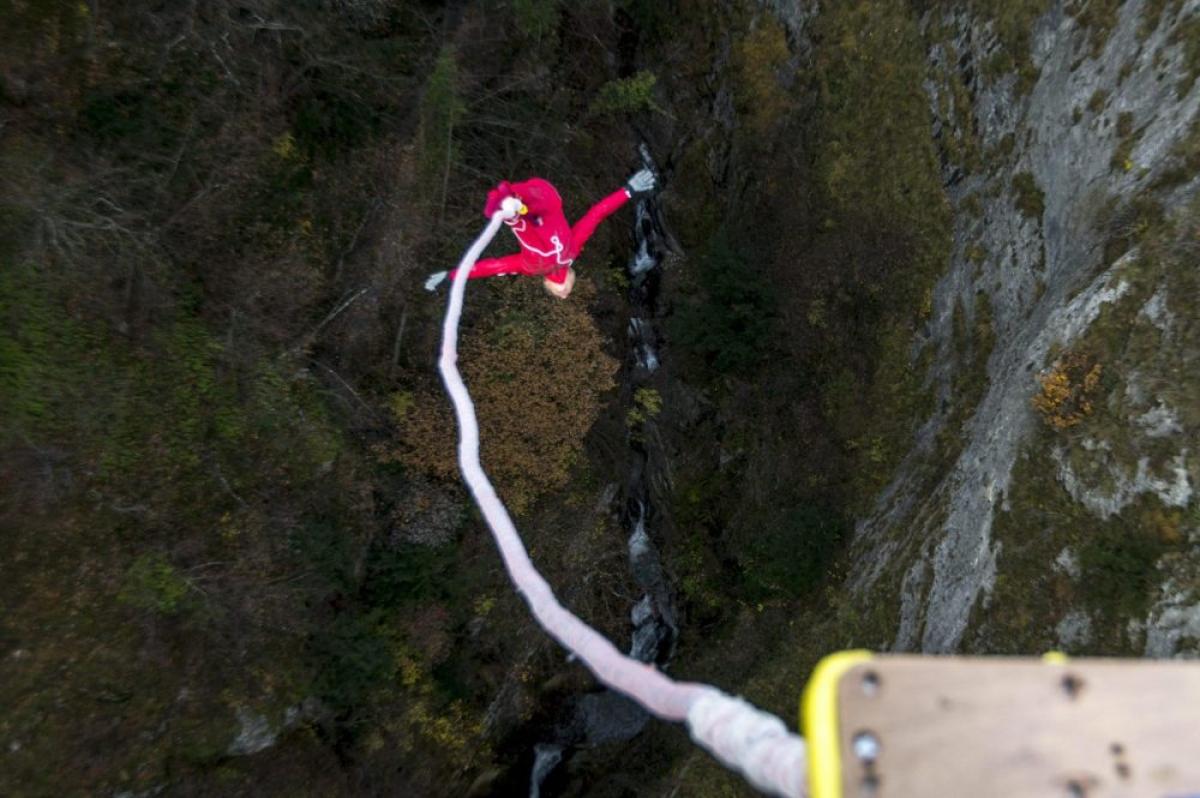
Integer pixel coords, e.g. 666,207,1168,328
838,656,1200,798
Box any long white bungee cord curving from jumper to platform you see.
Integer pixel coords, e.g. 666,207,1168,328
438,197,806,798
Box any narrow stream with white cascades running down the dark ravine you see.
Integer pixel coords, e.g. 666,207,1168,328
529,144,679,798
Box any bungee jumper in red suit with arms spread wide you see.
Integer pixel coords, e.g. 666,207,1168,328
425,169,656,299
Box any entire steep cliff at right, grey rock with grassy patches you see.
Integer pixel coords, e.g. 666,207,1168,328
850,2,1200,656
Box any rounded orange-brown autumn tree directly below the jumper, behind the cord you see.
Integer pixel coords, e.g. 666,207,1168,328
385,280,618,514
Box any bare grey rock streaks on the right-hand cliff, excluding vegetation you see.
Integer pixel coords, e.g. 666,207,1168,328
850,0,1200,653
